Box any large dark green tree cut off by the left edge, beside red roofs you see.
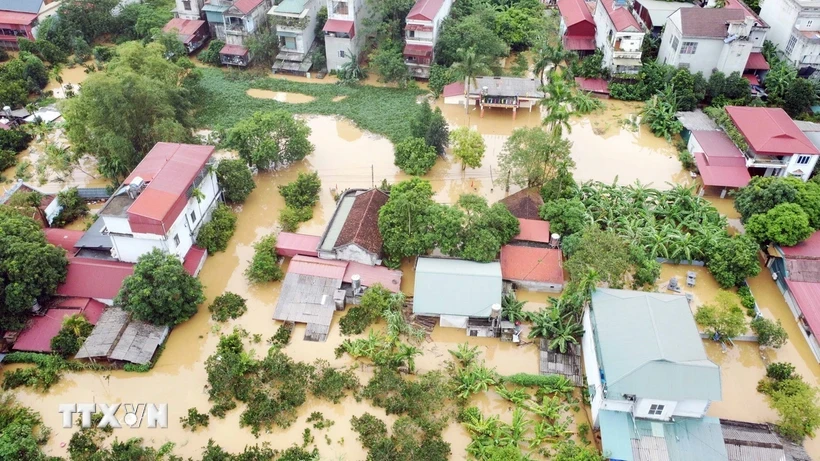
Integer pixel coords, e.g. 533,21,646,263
0,206,68,330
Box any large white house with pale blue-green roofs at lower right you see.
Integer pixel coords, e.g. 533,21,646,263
582,289,726,460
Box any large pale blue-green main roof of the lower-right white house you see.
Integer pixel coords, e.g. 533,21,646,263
592,288,721,401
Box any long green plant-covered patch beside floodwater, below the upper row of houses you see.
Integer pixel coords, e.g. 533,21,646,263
196,69,424,143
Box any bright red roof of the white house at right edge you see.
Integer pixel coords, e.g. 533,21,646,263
726,106,820,155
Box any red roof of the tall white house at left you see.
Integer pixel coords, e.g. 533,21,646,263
124,142,214,235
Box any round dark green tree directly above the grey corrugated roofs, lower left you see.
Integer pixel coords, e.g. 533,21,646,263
114,249,205,326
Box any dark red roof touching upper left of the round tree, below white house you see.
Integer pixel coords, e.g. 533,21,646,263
57,258,134,299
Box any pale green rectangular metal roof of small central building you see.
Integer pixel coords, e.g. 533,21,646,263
413,258,501,317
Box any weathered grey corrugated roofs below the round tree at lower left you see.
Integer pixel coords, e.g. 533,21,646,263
75,307,171,365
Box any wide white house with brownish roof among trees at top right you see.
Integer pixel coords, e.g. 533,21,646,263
658,8,767,78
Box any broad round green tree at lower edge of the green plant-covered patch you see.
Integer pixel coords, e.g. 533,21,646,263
228,110,313,169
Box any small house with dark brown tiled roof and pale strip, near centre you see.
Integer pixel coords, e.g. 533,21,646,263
318,189,387,266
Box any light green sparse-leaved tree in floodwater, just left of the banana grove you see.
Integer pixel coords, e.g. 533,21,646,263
498,127,575,187
